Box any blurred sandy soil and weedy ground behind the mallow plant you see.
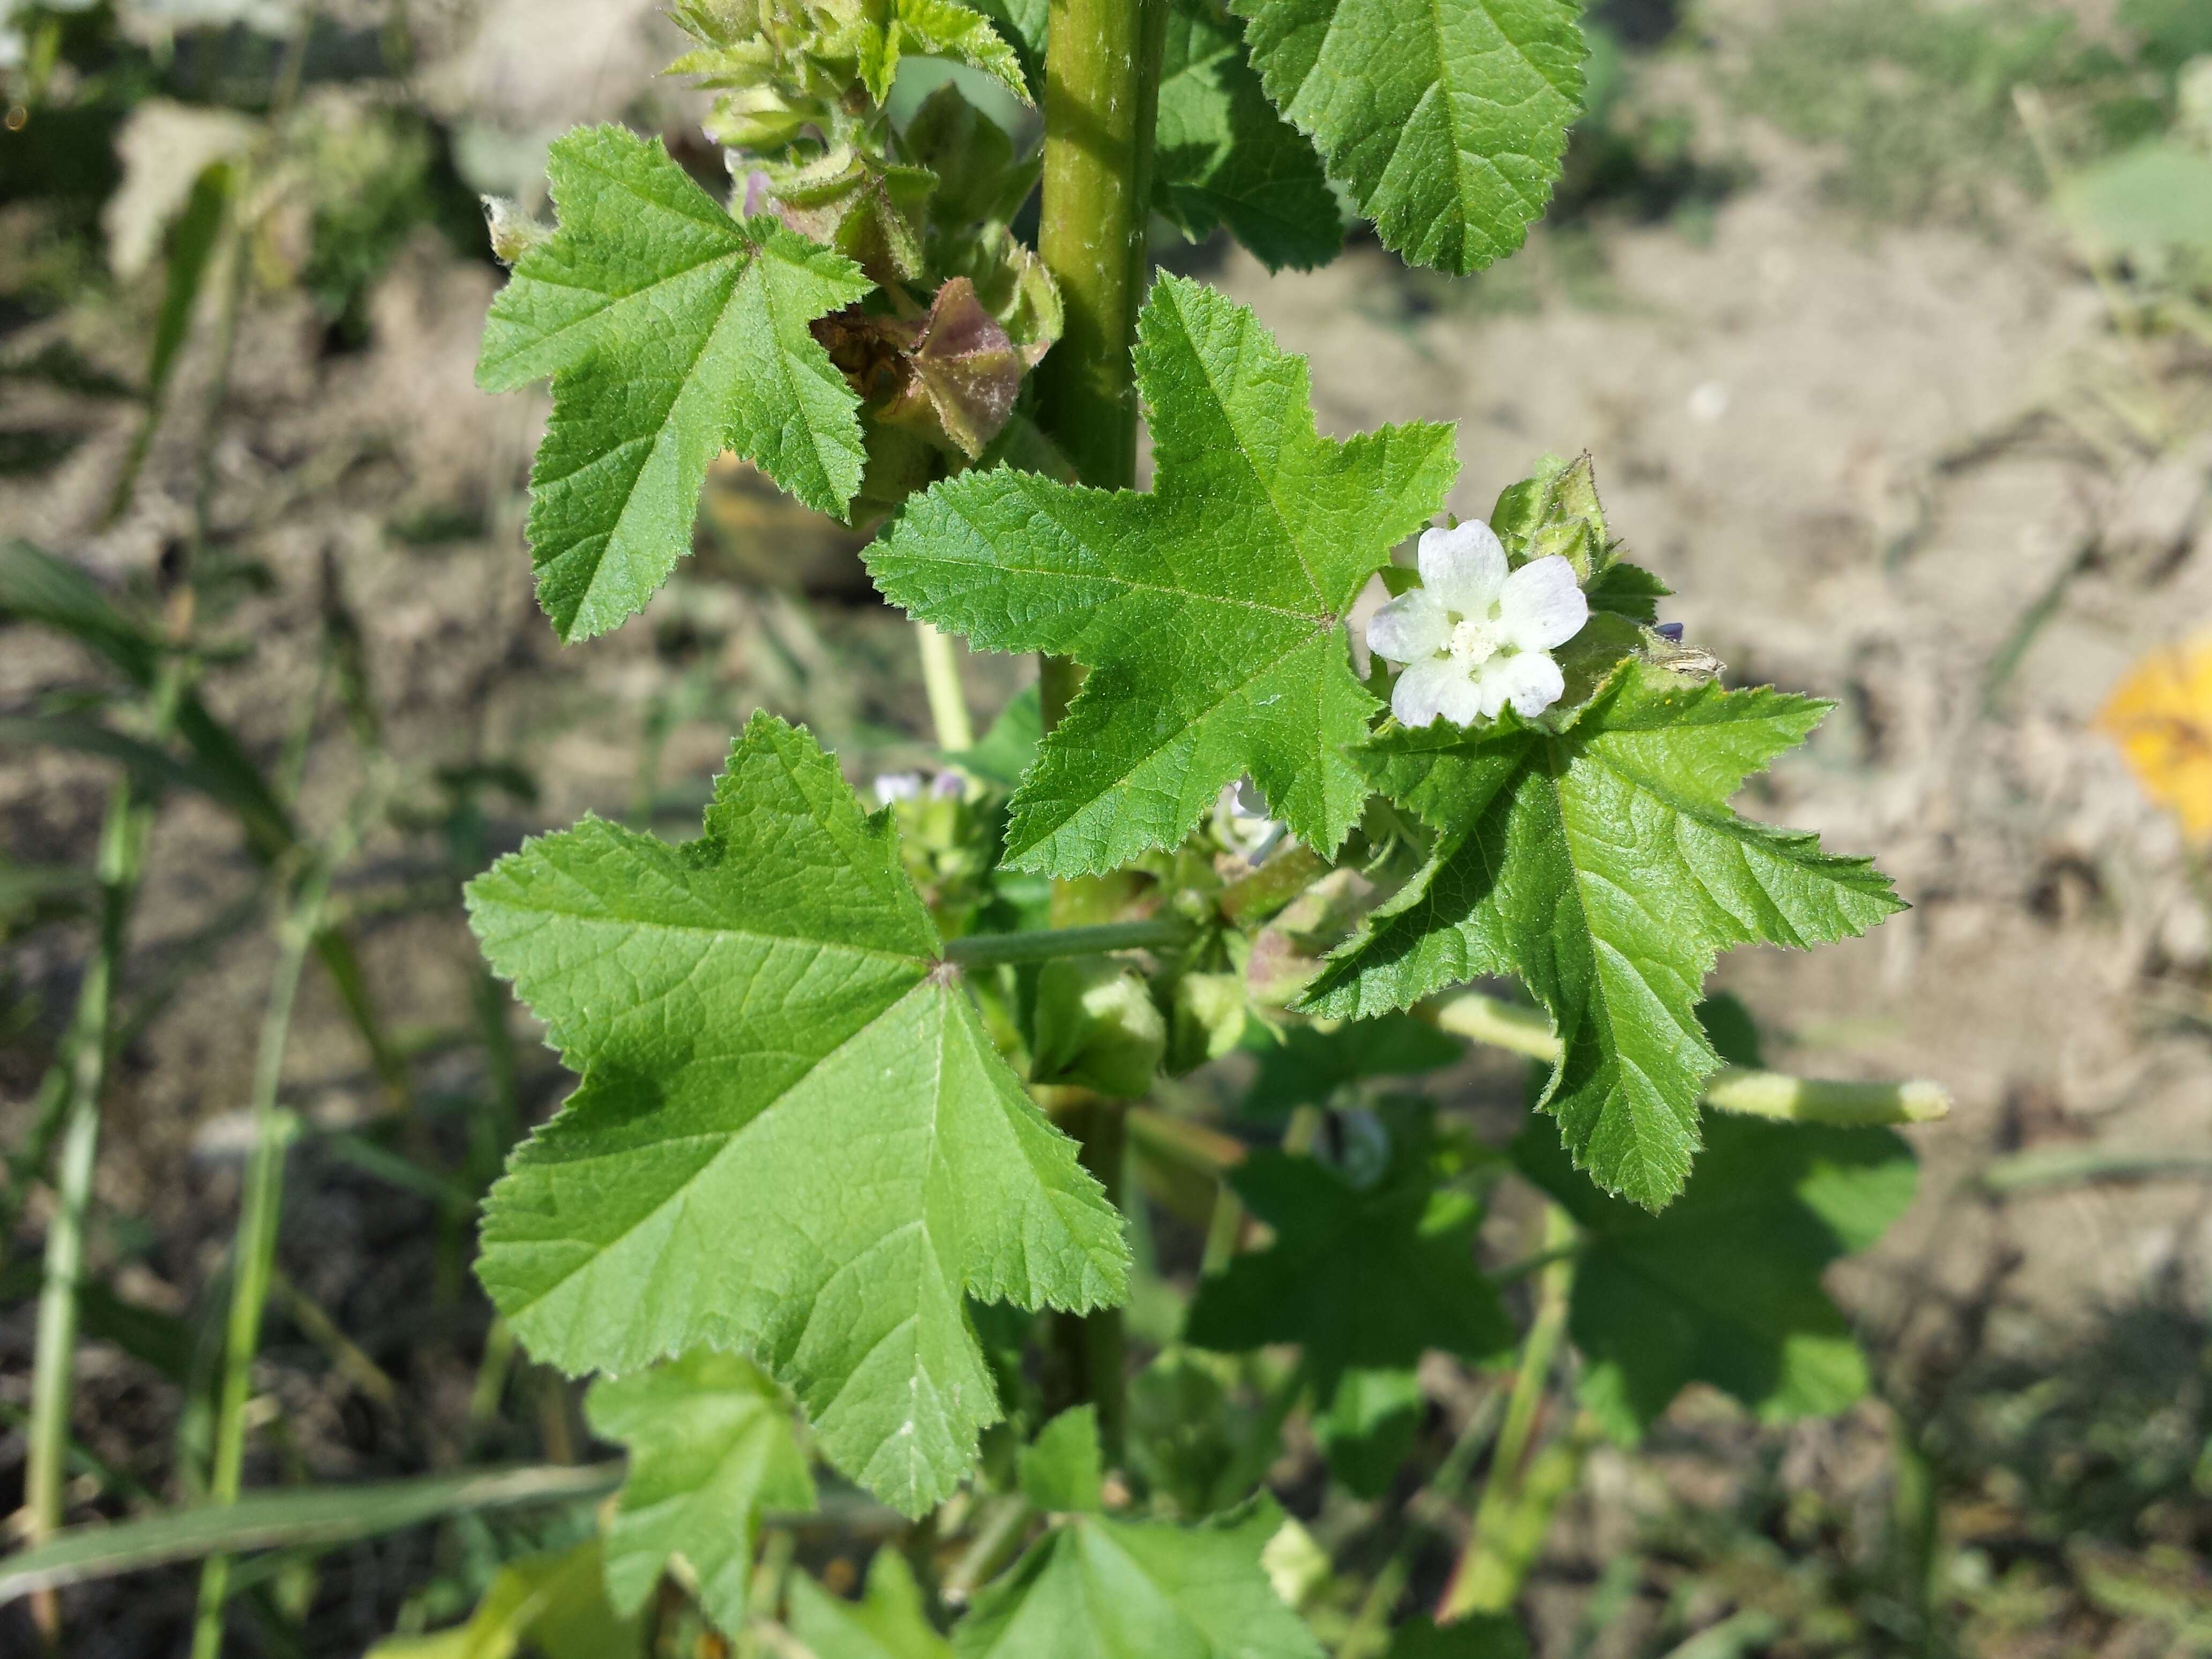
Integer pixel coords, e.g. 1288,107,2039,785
0,0,2212,1659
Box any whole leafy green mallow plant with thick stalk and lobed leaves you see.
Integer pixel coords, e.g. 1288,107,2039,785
407,0,1926,1659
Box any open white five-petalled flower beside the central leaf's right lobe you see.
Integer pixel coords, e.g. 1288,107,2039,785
1367,520,1590,726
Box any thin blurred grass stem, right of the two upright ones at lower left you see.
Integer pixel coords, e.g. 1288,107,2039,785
192,801,376,1659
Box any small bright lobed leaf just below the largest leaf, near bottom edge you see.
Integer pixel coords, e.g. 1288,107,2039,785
584,1349,814,1630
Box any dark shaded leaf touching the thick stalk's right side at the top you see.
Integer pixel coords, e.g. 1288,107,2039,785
1153,0,1345,270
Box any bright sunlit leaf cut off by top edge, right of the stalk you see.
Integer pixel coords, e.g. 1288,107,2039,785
1230,0,1584,274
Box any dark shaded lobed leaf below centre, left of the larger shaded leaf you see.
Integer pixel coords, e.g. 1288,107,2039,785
1183,1150,1513,1407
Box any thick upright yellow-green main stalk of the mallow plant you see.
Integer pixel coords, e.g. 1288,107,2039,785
1037,0,1168,1455
